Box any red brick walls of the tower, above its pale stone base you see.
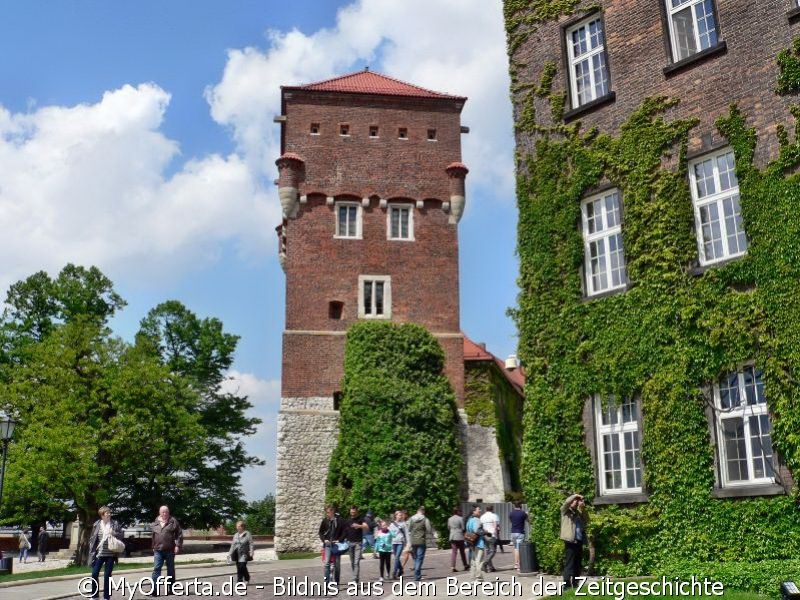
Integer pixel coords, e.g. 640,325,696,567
278,75,465,401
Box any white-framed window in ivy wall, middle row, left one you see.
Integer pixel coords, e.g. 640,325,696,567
581,189,628,296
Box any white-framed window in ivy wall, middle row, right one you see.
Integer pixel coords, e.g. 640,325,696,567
689,149,747,265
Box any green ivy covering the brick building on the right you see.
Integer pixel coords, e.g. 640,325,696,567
506,28,800,574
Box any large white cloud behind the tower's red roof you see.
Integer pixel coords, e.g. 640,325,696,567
206,0,514,201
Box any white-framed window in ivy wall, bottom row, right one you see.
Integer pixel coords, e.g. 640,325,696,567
714,365,775,487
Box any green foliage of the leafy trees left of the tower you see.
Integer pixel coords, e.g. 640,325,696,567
0,265,258,564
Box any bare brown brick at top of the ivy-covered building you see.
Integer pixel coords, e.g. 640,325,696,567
512,0,800,166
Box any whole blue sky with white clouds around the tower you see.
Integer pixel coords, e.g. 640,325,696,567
0,0,517,499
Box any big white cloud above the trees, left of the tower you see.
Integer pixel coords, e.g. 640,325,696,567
0,84,279,288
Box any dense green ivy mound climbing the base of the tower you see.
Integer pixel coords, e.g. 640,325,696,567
327,322,462,531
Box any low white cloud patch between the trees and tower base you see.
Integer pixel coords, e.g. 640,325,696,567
223,371,281,501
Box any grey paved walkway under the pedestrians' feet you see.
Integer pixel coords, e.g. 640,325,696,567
0,549,559,600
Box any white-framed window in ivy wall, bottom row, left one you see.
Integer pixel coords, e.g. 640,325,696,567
594,395,642,495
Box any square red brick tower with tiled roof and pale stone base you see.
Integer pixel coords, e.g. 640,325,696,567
275,70,467,552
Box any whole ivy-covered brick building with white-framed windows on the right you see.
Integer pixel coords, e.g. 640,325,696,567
504,0,800,573
